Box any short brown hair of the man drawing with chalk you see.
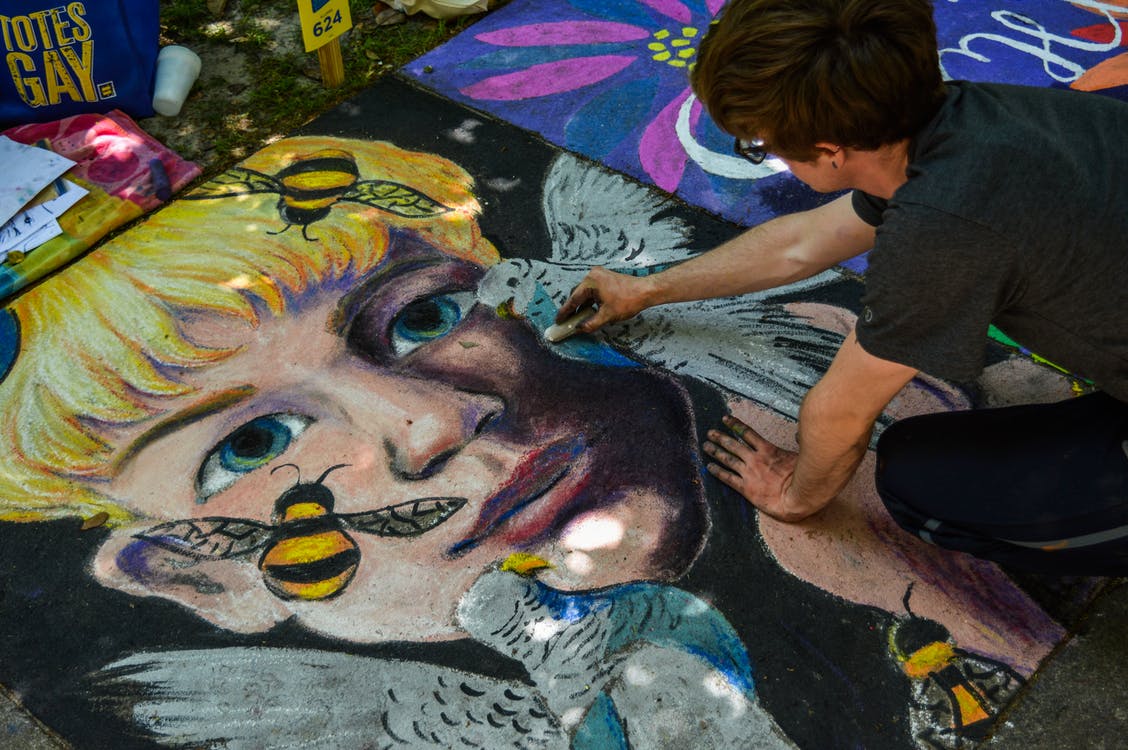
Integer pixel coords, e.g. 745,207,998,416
691,0,944,160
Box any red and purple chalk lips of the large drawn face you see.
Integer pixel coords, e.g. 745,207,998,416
447,435,587,557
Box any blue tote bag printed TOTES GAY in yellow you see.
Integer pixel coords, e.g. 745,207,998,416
0,0,160,129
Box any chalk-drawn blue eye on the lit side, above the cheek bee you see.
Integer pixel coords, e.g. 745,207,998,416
196,414,312,502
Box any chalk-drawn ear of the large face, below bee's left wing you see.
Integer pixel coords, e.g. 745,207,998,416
91,526,292,633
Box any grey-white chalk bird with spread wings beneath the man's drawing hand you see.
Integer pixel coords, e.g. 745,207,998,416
478,155,843,418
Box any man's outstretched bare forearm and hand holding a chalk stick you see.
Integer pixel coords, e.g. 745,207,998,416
556,195,874,332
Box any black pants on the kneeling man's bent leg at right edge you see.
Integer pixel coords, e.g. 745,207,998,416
876,394,1128,575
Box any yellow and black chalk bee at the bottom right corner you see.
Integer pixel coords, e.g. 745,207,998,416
889,584,1023,750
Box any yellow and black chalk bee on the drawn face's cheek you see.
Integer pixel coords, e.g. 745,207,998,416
135,464,466,601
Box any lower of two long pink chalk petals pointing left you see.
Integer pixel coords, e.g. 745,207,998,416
460,54,637,102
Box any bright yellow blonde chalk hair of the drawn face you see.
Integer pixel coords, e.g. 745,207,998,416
0,136,499,522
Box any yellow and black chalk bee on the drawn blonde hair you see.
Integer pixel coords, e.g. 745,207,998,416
185,149,450,239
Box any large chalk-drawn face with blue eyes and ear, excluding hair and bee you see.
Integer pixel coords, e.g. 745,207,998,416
92,232,706,641
